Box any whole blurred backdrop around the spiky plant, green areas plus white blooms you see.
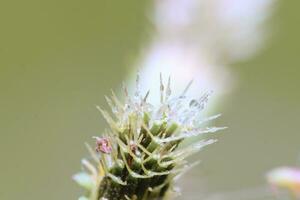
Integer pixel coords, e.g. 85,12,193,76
0,0,300,200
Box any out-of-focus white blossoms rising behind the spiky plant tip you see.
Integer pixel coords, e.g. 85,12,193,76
127,0,274,100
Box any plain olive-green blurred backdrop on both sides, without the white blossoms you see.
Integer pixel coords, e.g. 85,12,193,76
0,0,300,200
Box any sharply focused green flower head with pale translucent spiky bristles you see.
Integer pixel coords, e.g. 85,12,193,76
73,76,225,200
